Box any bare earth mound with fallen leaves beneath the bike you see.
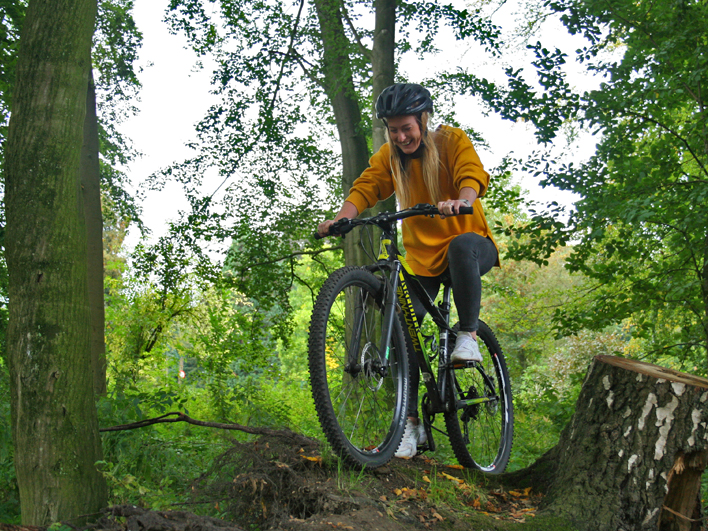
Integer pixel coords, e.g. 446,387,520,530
69,436,572,531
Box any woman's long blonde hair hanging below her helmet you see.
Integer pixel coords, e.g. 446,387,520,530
386,111,444,208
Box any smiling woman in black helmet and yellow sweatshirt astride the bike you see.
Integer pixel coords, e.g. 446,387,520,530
317,83,499,457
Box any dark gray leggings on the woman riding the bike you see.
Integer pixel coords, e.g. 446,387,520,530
403,232,498,418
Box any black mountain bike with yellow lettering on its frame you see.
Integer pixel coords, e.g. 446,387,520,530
308,204,514,474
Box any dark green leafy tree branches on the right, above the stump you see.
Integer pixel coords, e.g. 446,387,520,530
496,0,708,373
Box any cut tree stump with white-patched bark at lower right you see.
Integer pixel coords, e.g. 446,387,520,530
510,356,708,531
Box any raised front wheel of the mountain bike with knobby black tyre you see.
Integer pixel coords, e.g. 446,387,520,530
308,267,409,467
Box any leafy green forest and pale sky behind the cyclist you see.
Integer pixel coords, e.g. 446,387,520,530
0,0,708,522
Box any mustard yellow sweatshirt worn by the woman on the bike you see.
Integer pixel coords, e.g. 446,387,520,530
346,126,499,276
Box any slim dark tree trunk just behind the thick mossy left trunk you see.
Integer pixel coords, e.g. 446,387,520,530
80,71,106,397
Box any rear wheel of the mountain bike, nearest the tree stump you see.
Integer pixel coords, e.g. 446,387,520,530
445,321,514,474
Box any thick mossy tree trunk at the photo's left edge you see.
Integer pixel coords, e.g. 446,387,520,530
5,0,107,525
